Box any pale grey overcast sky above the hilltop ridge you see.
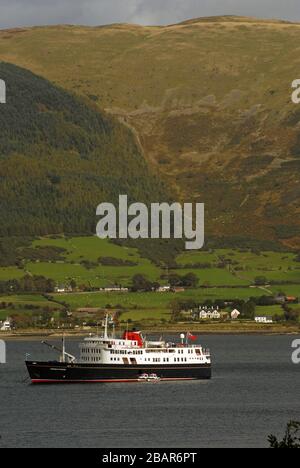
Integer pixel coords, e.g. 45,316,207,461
0,0,300,29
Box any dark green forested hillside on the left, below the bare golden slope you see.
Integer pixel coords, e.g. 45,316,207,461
0,63,168,237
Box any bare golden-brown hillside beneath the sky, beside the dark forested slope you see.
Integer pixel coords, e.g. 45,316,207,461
0,17,300,248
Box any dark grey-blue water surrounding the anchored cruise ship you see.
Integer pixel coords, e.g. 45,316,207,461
0,336,300,448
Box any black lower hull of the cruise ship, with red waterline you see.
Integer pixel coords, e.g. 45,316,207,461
26,361,211,384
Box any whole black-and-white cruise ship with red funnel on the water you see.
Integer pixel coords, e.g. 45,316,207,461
26,317,211,384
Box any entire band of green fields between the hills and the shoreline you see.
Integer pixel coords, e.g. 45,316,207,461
0,237,300,321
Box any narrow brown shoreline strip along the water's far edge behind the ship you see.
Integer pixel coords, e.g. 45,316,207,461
0,323,300,341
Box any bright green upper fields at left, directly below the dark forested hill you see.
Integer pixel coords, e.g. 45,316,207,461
0,237,164,287
